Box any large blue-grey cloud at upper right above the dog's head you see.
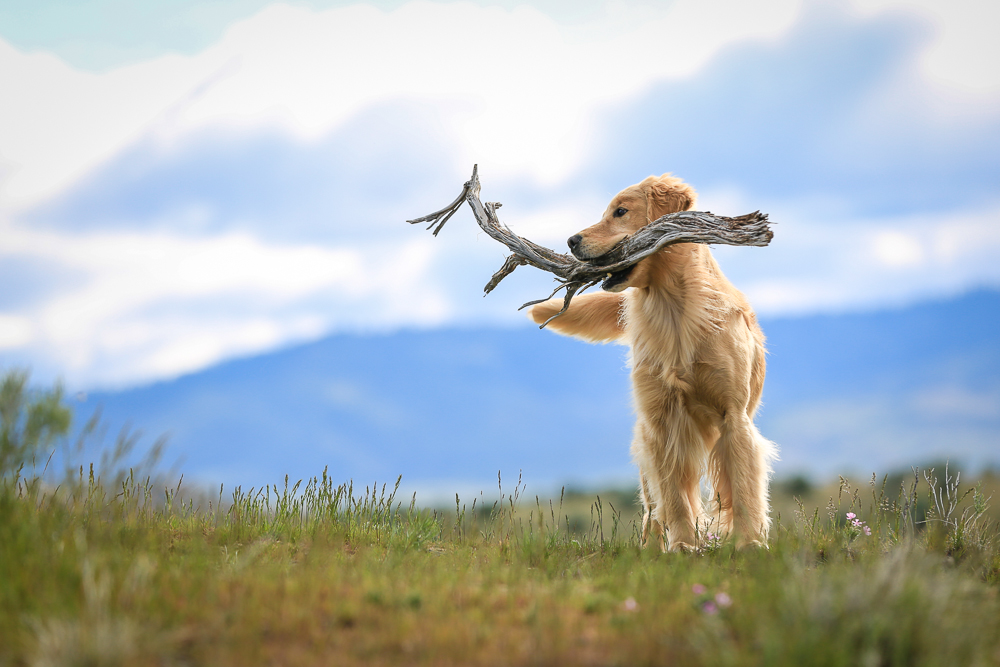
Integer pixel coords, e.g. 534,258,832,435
595,4,1000,217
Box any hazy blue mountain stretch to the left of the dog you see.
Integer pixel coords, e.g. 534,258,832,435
78,327,631,490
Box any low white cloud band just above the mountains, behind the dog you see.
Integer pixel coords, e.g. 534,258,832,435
0,192,1000,386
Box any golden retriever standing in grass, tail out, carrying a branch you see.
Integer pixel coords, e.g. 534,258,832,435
529,174,777,551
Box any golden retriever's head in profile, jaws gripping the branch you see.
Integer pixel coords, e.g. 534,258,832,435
567,174,698,292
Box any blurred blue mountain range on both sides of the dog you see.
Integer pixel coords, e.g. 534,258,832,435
78,291,1000,495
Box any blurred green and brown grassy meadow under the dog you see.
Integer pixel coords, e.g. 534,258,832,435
0,374,1000,665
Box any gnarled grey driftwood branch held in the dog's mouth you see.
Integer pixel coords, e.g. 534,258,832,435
407,165,774,328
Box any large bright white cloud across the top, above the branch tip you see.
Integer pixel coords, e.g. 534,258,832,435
0,0,798,209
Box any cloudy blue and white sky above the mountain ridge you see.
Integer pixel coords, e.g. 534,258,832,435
0,0,1000,388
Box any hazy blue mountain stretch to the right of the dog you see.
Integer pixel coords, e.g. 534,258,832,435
758,290,1000,475
